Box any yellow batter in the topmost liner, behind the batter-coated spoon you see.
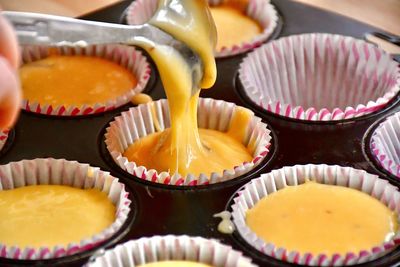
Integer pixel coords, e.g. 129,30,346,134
211,4,262,51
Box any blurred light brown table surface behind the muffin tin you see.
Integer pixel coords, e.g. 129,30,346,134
0,0,400,35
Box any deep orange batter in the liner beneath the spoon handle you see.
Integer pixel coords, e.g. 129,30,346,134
19,55,137,106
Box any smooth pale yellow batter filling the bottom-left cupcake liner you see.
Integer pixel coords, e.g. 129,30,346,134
0,185,116,248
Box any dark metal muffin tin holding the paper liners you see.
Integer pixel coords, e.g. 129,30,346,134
0,0,400,266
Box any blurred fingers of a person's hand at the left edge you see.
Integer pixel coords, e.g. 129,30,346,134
0,9,22,130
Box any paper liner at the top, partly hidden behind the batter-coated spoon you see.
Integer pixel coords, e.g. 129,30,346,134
126,0,279,58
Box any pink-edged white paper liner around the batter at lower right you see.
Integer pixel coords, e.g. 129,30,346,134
231,164,400,266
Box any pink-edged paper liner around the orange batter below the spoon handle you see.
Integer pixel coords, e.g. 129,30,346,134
22,45,151,116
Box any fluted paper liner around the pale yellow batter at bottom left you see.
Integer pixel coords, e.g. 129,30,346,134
0,158,131,260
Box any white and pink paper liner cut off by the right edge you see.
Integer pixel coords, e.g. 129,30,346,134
370,112,400,178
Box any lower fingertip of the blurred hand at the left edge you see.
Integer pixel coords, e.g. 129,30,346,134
0,56,21,130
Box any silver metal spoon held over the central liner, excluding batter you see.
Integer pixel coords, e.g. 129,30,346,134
2,11,203,95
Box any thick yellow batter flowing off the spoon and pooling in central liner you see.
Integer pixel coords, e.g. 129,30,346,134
124,0,252,179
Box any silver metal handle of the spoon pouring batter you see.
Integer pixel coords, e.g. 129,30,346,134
2,11,145,46
